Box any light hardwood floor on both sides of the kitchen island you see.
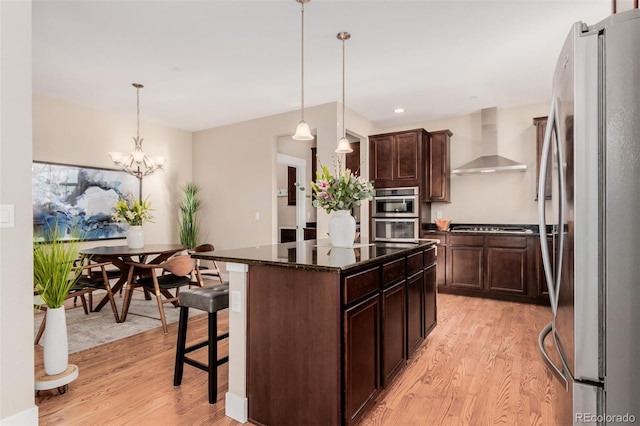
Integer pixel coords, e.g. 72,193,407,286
36,295,557,426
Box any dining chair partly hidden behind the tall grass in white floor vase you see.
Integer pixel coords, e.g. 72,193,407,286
33,257,120,345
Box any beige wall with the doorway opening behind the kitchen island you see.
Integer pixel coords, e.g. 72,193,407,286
193,103,379,249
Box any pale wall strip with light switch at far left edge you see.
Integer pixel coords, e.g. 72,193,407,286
0,1,38,425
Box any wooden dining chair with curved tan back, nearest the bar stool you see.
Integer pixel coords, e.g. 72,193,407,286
121,254,201,334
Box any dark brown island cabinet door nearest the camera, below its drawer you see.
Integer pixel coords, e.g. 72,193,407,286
344,293,380,422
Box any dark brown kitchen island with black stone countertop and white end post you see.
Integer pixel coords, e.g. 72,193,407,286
193,240,436,425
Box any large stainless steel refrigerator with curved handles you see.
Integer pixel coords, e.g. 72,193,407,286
538,9,640,425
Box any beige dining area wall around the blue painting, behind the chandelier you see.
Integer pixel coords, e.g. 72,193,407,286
33,93,192,245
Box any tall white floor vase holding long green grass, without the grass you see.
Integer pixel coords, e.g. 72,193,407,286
44,306,69,376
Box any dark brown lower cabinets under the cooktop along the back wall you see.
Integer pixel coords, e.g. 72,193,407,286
426,232,549,304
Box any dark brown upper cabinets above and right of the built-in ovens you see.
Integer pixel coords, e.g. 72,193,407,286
369,129,453,202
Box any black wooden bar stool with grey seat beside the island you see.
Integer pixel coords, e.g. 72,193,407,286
173,284,229,404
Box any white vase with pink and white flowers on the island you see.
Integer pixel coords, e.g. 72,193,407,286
296,160,374,247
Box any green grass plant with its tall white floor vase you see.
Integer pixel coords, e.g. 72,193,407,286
33,222,81,376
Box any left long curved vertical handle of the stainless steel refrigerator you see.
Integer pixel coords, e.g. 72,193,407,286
538,95,558,317
